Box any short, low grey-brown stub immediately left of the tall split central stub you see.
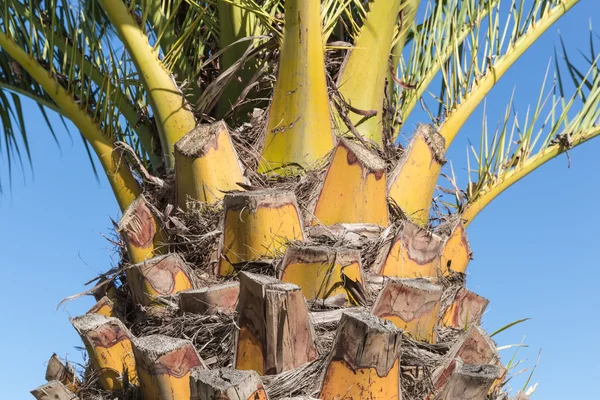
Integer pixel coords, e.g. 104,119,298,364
179,282,240,315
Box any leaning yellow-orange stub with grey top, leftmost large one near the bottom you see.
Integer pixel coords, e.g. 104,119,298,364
71,314,138,390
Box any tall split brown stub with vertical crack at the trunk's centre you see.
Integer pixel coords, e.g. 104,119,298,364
234,272,317,375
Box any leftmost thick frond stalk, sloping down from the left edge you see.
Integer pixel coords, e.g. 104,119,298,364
0,32,141,211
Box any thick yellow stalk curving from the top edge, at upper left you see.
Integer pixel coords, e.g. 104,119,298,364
98,0,196,168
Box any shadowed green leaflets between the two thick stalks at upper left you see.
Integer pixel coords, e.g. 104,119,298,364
0,0,159,180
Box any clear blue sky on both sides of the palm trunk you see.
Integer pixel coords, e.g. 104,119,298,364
0,0,600,399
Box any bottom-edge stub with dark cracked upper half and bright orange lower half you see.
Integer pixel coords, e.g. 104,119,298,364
319,311,402,400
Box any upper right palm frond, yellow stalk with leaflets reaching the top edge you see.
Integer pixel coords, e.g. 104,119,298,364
399,0,578,142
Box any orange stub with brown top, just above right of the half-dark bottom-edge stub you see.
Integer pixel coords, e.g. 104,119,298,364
373,279,442,343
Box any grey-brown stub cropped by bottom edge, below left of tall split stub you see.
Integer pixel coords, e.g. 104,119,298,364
190,368,268,400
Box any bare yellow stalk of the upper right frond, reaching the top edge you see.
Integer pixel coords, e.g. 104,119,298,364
440,0,579,148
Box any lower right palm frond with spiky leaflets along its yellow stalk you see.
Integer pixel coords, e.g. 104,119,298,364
460,34,600,223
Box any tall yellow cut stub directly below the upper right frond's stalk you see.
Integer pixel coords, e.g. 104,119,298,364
388,125,445,226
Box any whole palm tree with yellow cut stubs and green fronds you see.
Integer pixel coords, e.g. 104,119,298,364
0,0,600,399
